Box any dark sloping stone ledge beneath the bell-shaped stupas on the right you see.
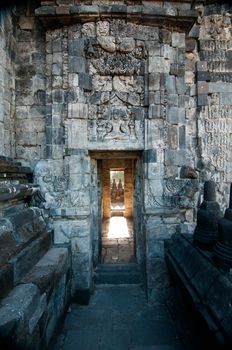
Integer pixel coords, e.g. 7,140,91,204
165,235,232,346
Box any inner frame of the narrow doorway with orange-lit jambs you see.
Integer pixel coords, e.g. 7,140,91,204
89,151,144,266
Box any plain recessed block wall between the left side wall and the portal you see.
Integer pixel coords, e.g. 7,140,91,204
13,1,46,168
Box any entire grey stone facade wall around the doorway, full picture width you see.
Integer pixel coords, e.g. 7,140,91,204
2,0,232,300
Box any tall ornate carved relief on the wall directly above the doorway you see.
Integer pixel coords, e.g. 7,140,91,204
86,21,146,143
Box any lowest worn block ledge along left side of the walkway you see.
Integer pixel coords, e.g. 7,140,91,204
0,247,70,349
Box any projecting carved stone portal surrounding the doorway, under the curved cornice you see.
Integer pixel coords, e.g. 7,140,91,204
35,2,199,302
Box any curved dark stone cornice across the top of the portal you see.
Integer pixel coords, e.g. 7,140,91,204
35,5,198,31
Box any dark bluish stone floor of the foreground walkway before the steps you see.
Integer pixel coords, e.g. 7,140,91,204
50,285,186,350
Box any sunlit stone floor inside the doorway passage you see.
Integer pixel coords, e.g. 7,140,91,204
102,216,134,263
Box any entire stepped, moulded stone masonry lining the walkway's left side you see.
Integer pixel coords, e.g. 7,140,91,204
0,157,71,350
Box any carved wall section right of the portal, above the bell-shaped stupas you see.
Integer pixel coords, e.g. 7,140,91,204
186,3,232,209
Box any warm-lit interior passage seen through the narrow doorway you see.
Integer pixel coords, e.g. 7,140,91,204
100,159,136,263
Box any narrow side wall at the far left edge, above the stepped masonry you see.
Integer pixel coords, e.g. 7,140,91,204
0,9,16,157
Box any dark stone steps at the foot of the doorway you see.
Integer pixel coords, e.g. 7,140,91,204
95,263,141,284
